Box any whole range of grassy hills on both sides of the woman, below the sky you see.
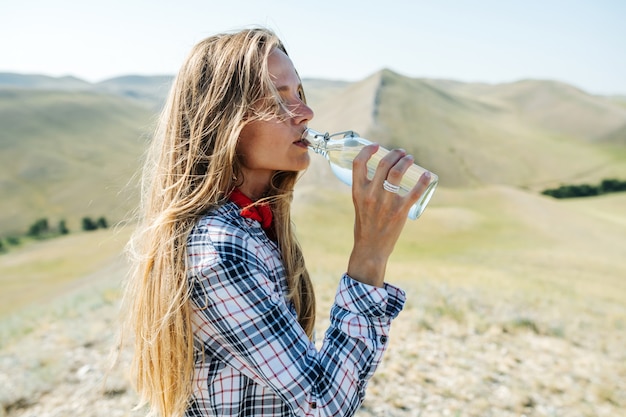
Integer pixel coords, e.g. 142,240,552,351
0,70,626,236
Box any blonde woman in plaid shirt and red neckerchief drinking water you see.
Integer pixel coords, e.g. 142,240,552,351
125,29,427,416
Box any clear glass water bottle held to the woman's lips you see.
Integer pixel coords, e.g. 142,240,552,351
302,128,439,220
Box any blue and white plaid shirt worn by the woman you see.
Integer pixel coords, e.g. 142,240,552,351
186,202,405,417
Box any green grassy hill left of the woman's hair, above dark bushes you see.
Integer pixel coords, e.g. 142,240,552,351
0,89,154,236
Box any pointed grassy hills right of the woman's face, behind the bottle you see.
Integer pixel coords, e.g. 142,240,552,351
304,70,626,190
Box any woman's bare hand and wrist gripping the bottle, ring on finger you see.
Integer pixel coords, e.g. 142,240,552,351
347,144,430,287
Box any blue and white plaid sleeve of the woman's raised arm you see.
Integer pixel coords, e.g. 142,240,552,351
189,223,405,416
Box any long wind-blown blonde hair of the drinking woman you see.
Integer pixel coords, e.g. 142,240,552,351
123,28,315,417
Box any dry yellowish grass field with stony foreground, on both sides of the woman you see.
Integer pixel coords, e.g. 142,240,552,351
0,186,626,417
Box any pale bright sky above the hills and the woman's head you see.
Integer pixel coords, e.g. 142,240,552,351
0,0,626,95
